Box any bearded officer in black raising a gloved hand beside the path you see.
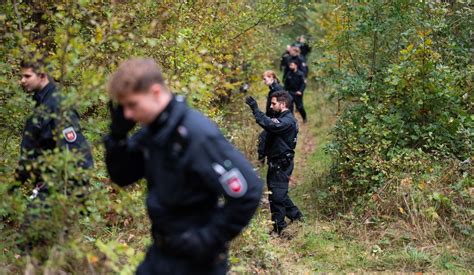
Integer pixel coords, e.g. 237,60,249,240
246,92,303,234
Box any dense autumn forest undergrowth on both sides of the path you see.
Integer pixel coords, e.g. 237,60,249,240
0,0,474,274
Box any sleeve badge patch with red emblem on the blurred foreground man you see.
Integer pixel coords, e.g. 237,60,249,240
214,164,247,198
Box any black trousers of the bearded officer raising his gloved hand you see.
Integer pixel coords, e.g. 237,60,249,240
267,159,302,233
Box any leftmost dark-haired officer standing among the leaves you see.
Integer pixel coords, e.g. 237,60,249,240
17,62,93,198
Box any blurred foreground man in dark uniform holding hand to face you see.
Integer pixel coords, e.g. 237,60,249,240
105,58,262,274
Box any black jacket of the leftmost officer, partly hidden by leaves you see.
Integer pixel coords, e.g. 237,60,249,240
18,82,93,182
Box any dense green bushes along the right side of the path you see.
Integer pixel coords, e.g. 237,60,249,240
312,1,474,244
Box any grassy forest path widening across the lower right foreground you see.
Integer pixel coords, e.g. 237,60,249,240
241,77,470,274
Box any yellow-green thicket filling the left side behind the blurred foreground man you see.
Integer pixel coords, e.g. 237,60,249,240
0,0,299,273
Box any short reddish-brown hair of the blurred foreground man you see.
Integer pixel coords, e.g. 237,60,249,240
107,58,164,99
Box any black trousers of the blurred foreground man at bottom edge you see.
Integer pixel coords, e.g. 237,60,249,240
136,244,227,275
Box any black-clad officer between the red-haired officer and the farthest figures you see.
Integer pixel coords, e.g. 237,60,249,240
285,62,307,122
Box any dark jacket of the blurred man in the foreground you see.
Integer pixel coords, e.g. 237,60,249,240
105,97,262,258
